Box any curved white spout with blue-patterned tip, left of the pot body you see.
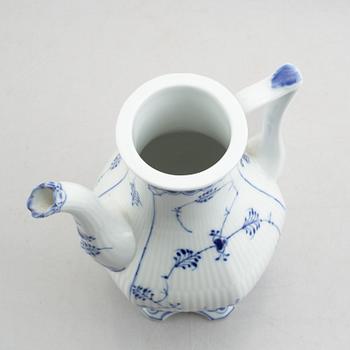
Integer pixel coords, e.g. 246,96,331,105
27,181,135,272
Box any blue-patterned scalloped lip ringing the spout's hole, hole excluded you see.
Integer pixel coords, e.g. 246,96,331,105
27,181,67,218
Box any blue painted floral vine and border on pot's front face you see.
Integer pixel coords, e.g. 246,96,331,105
130,161,280,308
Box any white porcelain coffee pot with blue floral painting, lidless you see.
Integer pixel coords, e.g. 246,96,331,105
27,64,301,320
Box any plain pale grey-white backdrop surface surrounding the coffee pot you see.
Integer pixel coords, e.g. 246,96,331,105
0,0,350,350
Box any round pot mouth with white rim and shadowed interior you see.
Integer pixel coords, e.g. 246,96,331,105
116,74,247,191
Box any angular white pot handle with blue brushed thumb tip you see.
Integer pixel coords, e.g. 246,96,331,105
236,64,302,179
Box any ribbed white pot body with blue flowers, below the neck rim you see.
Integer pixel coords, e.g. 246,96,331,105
94,152,285,311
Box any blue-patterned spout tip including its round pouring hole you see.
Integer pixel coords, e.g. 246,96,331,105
27,181,67,218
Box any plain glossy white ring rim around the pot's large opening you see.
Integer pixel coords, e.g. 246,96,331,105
116,73,248,191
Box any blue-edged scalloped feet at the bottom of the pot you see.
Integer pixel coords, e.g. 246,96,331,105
141,305,235,321
